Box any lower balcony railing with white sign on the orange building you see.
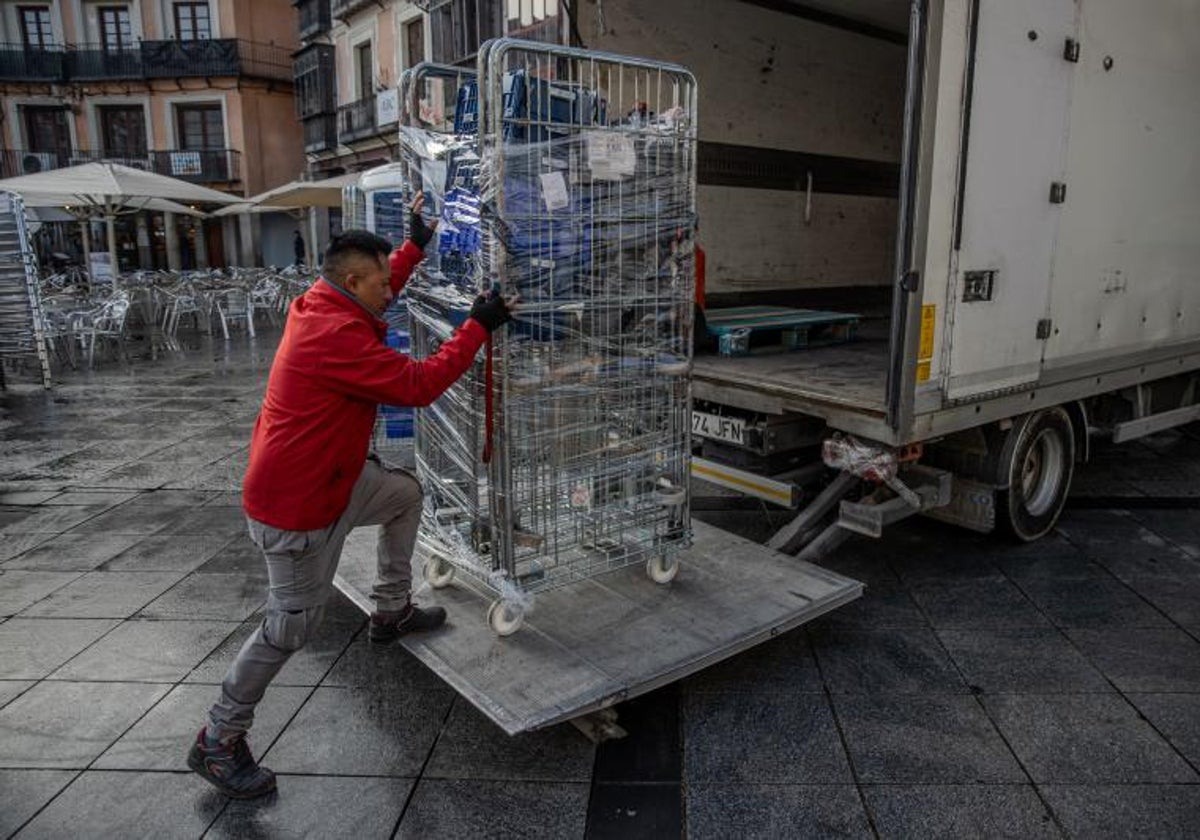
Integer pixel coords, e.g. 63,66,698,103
0,149,241,184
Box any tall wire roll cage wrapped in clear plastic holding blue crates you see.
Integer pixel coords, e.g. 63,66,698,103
401,40,697,632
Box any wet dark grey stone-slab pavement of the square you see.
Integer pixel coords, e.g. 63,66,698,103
0,335,1200,840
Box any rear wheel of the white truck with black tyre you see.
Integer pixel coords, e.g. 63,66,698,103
996,407,1075,542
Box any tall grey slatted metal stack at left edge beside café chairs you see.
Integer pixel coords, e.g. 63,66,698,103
0,191,50,388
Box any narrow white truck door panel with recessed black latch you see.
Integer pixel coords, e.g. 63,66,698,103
946,0,1078,400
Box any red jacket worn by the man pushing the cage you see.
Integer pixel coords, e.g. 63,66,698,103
242,242,487,530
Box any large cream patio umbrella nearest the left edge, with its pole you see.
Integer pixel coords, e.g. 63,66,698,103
0,163,238,277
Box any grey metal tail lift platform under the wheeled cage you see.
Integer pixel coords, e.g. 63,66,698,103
335,520,863,734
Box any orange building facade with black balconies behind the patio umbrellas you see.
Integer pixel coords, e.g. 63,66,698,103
0,0,306,268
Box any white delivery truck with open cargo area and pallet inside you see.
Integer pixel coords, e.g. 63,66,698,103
576,0,1200,557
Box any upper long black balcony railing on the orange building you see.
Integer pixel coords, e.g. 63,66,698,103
0,38,292,82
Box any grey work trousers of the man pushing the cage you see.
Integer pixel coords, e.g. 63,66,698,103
208,461,421,740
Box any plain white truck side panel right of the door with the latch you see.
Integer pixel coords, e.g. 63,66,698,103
1045,0,1200,370
